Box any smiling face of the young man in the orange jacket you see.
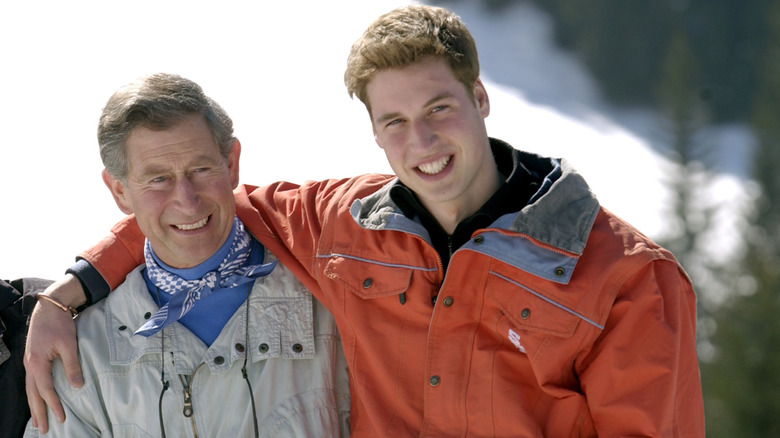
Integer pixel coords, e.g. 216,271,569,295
366,57,496,226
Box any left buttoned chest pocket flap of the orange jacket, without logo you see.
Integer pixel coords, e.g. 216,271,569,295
324,256,414,299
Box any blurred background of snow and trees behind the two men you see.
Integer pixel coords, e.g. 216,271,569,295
0,0,780,437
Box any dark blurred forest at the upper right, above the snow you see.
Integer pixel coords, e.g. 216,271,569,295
512,0,776,123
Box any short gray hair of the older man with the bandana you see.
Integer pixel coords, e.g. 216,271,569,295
98,73,235,182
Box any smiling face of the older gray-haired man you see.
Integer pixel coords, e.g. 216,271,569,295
103,114,241,268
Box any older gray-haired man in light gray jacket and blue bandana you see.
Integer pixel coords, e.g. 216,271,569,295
26,74,349,437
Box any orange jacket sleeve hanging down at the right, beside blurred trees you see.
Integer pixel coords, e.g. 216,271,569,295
575,260,704,437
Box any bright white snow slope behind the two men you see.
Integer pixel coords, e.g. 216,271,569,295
0,0,752,279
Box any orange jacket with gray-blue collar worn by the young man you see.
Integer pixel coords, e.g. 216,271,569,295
82,161,704,437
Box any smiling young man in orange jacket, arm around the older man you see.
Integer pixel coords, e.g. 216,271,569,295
25,5,704,437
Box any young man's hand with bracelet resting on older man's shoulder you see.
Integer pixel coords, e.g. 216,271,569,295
24,274,85,433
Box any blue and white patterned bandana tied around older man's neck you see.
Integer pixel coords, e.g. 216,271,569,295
135,217,276,337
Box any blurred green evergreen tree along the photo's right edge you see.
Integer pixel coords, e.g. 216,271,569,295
702,3,780,438
